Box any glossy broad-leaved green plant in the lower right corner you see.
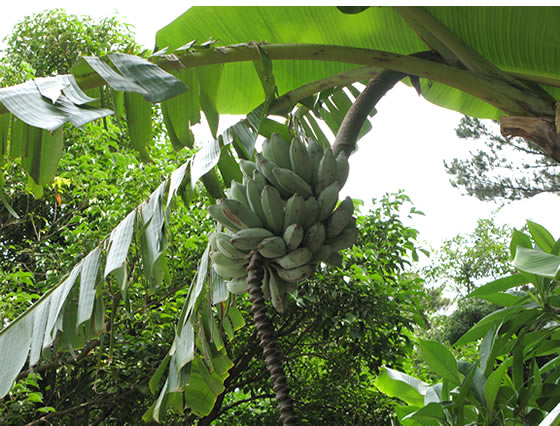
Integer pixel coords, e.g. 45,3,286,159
375,221,560,426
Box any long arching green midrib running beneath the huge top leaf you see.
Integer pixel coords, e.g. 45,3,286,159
0,43,560,116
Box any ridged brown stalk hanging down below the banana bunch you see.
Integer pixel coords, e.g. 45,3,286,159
247,251,297,425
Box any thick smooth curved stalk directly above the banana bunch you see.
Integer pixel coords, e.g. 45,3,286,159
333,70,407,157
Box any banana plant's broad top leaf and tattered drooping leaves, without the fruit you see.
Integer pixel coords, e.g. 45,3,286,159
0,7,560,420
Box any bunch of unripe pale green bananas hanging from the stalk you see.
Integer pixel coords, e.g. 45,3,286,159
208,134,358,312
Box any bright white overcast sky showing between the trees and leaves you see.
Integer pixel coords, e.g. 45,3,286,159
0,0,560,250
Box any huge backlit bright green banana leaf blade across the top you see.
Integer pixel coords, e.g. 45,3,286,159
156,6,560,119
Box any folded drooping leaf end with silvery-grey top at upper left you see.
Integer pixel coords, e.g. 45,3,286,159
0,54,185,191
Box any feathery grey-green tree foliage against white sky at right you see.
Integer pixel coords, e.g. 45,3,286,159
444,116,560,201
